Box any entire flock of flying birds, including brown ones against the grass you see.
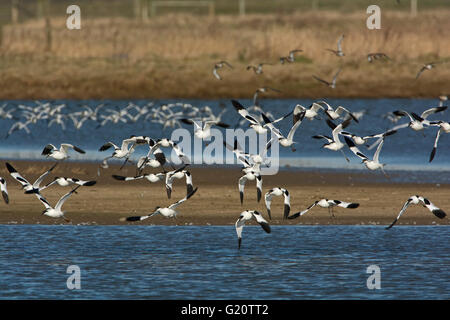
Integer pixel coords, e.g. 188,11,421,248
0,35,450,248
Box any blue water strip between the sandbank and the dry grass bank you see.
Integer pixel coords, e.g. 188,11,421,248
0,99,450,178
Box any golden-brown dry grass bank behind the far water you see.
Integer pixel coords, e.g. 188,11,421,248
0,10,450,99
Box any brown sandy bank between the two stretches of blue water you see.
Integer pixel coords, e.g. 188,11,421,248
0,161,450,225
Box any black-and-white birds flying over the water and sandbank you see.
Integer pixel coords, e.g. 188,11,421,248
0,91,450,248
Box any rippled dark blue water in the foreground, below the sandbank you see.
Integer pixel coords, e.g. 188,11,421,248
0,225,450,300
